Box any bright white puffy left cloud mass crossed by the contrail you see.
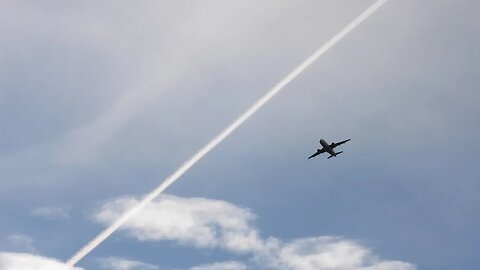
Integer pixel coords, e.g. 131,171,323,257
95,195,262,252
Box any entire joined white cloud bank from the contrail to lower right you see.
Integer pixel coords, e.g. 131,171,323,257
94,195,415,270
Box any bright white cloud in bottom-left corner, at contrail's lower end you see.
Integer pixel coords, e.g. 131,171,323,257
0,252,82,270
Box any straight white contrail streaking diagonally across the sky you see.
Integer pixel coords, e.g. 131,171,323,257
66,0,388,266
